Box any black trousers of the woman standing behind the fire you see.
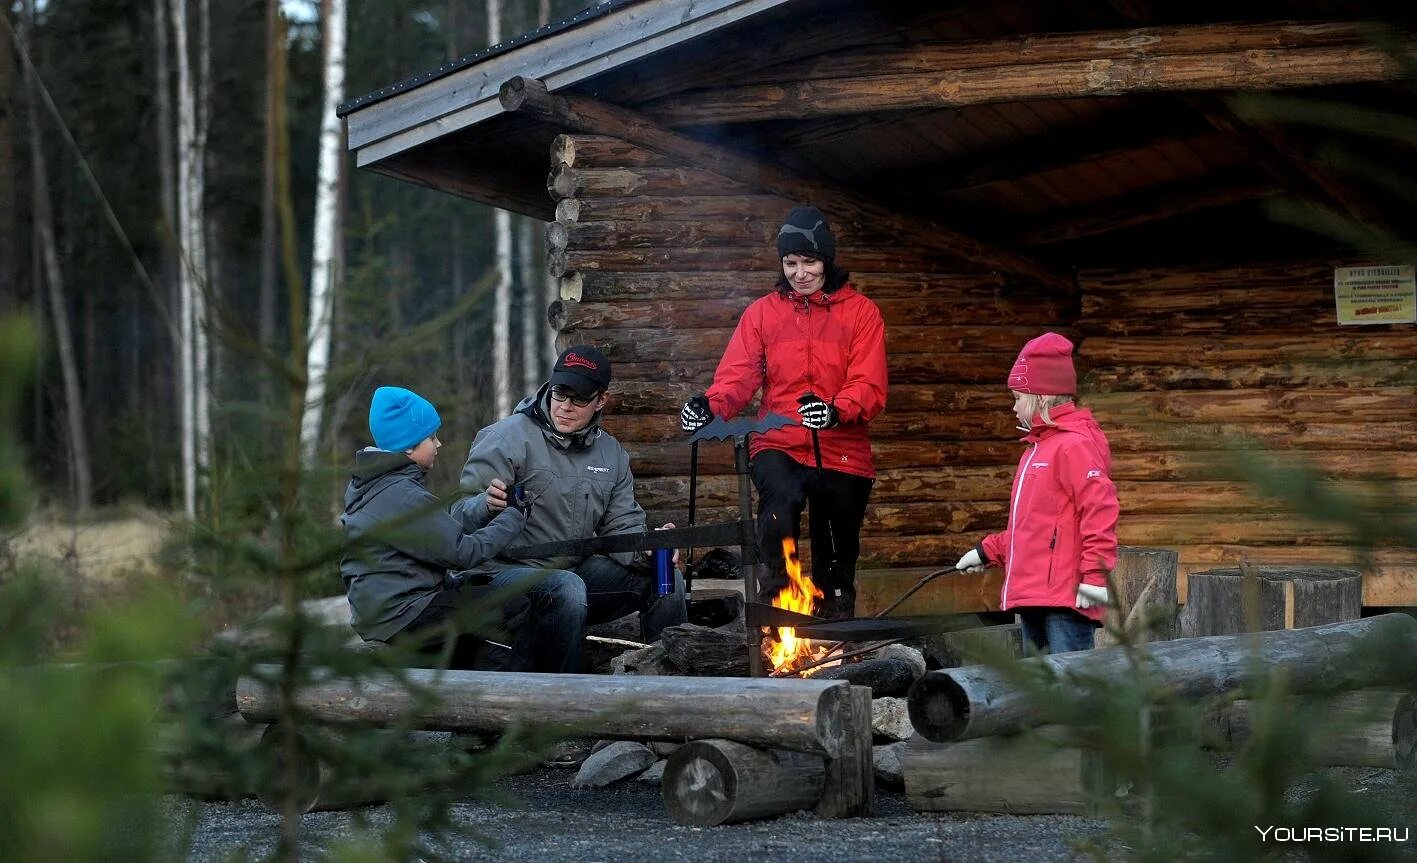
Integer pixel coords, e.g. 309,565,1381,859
751,449,874,616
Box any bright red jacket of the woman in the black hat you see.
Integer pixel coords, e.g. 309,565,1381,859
707,285,886,478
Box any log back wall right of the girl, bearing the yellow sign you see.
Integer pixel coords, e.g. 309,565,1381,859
1077,261,1417,607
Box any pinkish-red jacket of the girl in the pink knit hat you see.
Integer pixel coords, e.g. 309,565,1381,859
981,404,1118,621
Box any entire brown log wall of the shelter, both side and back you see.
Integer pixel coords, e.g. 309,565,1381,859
547,135,1417,612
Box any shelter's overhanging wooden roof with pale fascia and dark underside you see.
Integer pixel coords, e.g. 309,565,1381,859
346,0,1417,273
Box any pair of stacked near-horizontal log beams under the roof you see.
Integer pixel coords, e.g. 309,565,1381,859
640,24,1400,126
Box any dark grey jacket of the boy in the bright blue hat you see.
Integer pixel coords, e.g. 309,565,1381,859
340,449,526,641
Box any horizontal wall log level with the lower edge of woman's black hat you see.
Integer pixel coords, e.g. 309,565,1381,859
547,245,959,276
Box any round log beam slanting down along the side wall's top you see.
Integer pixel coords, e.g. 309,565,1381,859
502,78,1077,293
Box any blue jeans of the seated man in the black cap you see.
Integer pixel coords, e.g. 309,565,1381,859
492,555,689,673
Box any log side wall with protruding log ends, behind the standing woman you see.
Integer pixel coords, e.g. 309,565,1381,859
547,135,1076,611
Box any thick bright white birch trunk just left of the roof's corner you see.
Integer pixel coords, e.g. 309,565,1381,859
300,0,344,466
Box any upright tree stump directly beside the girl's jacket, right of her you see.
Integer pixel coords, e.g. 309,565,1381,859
1097,546,1179,648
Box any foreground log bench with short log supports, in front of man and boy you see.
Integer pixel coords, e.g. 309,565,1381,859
237,666,874,825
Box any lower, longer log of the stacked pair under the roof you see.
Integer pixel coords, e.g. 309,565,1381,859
640,45,1399,126
